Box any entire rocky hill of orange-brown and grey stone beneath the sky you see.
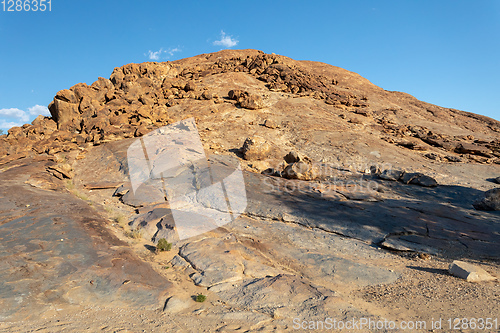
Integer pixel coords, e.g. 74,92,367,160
0,50,500,332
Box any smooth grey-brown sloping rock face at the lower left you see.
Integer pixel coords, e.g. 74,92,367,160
0,157,172,321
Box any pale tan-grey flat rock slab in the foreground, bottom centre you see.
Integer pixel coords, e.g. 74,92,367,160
175,217,400,288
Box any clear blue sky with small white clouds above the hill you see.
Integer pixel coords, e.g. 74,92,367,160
0,0,500,130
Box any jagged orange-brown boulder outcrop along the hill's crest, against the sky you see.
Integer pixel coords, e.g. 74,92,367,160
0,51,500,169
